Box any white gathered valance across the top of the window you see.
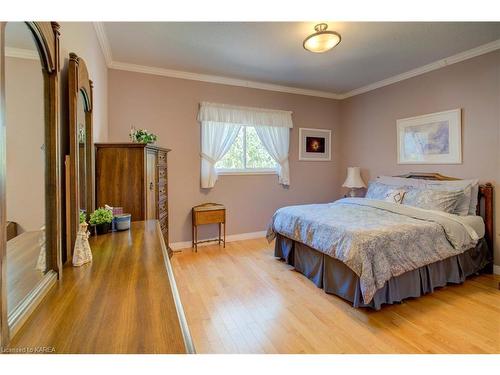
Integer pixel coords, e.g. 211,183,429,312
198,102,293,128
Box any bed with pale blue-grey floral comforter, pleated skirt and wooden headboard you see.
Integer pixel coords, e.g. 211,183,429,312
268,173,493,310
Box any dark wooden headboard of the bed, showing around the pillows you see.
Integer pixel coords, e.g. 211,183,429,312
397,172,494,251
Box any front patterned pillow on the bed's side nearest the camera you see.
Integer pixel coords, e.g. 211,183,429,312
403,187,463,214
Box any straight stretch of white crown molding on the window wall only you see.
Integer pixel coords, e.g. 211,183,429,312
109,61,339,99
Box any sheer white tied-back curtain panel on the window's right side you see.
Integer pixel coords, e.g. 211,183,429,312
255,126,290,185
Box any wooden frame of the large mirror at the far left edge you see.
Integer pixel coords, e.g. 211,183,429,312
0,22,62,347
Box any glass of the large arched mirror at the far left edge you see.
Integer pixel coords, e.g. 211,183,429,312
5,22,47,315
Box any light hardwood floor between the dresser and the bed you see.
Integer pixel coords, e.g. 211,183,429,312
172,239,500,353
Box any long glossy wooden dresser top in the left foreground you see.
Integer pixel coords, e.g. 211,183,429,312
9,220,194,353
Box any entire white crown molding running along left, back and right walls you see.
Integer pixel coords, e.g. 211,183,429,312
93,22,500,100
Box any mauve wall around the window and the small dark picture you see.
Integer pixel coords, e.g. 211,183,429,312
108,70,341,243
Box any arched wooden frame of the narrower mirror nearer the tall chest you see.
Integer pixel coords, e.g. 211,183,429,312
66,53,94,262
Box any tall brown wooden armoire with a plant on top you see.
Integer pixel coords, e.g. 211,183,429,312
95,143,171,254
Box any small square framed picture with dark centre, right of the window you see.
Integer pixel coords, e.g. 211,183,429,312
299,128,332,161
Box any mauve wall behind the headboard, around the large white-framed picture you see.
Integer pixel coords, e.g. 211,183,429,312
337,51,500,265
